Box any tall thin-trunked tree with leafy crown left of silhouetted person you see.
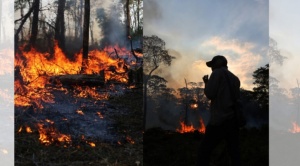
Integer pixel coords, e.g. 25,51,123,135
143,36,174,128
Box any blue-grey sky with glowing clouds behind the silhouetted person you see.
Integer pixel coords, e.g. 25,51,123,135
144,0,269,90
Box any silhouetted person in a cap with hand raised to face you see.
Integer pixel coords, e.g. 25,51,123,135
197,55,241,166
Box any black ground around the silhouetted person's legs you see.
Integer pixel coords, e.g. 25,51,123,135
144,126,269,166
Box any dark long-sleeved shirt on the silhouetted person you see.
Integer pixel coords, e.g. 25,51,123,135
204,67,240,125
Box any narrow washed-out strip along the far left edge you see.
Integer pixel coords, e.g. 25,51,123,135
0,1,14,166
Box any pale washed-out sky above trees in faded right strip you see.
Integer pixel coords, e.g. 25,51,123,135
270,0,300,90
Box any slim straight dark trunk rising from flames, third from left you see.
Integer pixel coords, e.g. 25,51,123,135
81,0,90,73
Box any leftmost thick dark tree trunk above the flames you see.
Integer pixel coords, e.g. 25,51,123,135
29,0,40,48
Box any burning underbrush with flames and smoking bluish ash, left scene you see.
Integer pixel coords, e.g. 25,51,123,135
15,43,142,163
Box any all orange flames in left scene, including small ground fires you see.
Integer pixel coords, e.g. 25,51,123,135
15,42,142,147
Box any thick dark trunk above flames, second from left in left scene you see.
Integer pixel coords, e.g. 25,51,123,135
55,0,66,51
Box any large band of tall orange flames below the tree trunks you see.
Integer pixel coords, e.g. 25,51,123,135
15,42,139,109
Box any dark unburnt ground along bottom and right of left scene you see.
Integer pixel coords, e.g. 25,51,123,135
15,85,143,166
